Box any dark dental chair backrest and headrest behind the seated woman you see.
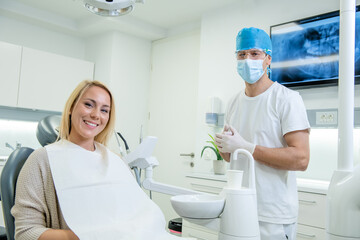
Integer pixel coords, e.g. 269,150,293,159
0,115,60,240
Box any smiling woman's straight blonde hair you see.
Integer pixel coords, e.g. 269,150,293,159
58,80,115,145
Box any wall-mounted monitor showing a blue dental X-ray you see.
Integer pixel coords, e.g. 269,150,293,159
270,6,360,88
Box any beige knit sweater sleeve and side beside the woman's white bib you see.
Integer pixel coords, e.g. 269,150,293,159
11,148,69,240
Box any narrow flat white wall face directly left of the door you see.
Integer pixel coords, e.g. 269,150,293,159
110,33,151,150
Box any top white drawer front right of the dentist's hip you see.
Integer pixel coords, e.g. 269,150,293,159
298,192,326,228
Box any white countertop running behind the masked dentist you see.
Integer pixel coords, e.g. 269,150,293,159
186,172,330,194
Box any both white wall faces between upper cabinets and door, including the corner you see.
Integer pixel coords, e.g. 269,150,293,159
86,32,151,151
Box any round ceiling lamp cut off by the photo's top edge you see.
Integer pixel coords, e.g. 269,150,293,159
84,0,144,17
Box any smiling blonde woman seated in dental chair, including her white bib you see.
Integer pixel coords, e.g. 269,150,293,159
12,81,181,240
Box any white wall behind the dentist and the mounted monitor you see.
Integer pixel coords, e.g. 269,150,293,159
195,0,360,180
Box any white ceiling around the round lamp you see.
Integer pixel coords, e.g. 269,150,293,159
0,0,238,40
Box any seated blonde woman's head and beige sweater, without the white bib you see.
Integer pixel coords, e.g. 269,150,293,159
12,81,115,240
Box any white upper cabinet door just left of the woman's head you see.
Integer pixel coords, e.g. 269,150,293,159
18,47,94,111
